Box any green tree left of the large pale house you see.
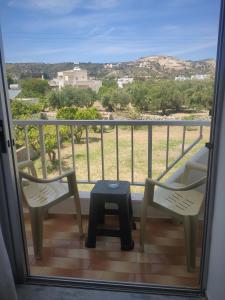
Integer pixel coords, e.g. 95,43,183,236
20,78,49,98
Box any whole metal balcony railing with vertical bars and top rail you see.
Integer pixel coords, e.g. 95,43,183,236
14,120,210,185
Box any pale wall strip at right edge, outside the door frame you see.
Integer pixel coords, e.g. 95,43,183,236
206,97,225,300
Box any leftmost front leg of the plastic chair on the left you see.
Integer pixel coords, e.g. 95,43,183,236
30,208,44,259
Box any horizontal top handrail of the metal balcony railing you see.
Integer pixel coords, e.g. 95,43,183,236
13,119,211,126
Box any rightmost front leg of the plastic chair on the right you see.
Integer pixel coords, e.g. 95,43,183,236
184,216,197,272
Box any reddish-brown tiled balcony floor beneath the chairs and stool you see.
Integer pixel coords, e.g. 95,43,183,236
25,214,202,287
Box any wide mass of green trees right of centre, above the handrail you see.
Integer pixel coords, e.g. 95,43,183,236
99,80,213,115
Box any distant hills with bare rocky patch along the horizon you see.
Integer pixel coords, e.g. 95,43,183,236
6,56,215,79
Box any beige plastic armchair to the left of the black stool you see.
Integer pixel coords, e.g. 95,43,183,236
18,160,83,259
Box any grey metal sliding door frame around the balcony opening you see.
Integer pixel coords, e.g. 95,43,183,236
0,0,225,296
